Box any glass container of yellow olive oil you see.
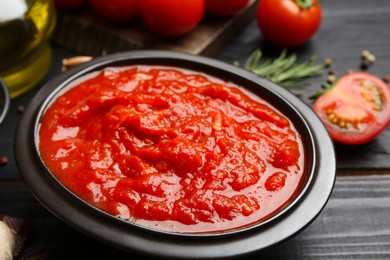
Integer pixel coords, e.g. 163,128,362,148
0,0,56,97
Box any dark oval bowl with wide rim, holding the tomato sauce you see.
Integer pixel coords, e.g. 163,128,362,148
15,51,336,259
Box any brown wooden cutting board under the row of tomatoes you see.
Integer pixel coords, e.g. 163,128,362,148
52,0,258,56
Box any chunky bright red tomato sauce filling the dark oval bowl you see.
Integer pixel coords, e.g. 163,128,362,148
38,66,304,232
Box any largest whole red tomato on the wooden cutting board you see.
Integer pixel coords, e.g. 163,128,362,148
140,0,205,37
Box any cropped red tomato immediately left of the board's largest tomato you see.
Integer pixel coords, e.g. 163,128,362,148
89,0,139,22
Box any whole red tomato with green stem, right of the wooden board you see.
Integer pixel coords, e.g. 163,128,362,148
256,0,321,47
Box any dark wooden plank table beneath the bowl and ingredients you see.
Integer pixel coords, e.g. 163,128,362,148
0,0,390,259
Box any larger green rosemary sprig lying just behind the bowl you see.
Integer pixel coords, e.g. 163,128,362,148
244,49,326,87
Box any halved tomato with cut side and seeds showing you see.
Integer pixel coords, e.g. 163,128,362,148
313,72,390,144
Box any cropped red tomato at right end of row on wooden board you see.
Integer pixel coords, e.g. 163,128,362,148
206,0,249,16
